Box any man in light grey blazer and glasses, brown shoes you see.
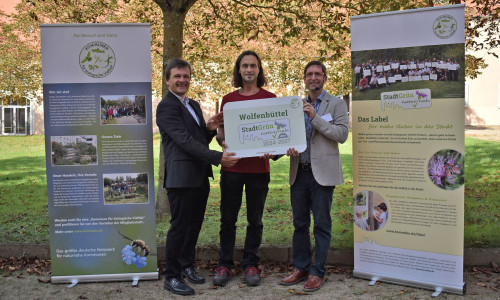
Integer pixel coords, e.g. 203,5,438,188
281,61,349,292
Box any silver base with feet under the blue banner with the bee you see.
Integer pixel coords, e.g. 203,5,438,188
50,272,160,288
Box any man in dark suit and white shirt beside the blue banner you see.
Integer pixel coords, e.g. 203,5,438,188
156,59,238,295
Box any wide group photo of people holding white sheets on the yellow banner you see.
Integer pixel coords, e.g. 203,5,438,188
351,44,465,100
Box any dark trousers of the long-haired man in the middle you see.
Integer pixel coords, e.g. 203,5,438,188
219,171,269,270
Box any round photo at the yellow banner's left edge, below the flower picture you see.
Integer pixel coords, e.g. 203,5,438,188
353,190,388,231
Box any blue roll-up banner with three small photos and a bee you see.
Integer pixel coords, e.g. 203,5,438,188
41,24,158,284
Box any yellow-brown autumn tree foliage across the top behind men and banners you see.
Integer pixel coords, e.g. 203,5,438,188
0,0,500,102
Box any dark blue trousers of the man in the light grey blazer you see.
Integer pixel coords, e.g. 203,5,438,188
290,166,335,277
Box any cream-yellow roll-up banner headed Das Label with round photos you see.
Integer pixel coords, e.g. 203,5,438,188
351,5,465,294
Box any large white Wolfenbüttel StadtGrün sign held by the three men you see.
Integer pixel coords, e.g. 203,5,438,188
224,96,307,157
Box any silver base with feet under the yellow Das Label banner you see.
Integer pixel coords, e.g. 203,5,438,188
352,270,465,297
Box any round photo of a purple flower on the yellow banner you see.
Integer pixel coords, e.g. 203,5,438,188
427,149,465,190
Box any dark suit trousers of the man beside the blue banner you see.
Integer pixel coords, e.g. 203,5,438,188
165,178,210,279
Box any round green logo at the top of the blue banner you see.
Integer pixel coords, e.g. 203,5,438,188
79,42,116,78
